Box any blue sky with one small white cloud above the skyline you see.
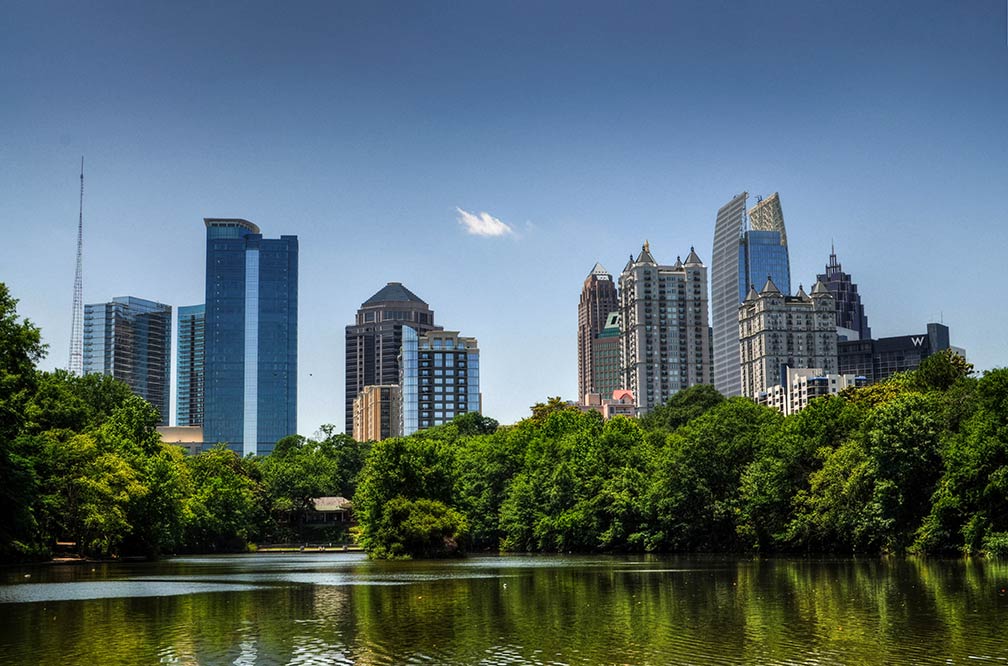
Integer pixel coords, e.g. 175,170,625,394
0,0,1008,436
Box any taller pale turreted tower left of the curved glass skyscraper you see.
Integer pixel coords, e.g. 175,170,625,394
619,243,711,413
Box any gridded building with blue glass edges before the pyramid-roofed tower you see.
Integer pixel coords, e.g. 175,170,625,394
399,326,483,435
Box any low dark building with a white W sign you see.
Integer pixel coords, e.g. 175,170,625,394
837,323,953,384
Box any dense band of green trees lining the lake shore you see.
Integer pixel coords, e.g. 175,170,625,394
0,283,1008,561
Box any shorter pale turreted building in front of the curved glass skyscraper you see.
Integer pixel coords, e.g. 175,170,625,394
738,279,838,399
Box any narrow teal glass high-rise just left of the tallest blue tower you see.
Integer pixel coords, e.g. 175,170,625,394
175,304,207,426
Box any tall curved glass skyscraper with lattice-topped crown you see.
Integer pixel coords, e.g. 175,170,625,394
711,192,791,396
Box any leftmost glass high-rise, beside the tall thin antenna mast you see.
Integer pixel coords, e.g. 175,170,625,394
84,296,171,425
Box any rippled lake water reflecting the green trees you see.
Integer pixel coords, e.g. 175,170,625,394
0,553,1008,665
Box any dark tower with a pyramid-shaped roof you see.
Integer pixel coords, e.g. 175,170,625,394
346,282,439,434
